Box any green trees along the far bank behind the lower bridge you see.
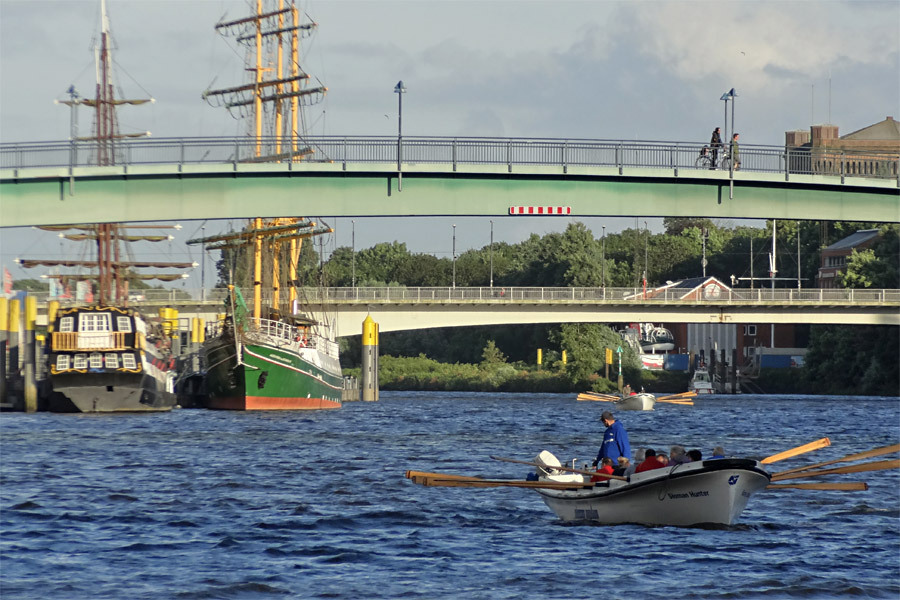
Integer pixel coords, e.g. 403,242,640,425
219,218,888,395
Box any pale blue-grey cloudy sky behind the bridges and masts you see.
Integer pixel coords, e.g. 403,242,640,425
0,0,900,285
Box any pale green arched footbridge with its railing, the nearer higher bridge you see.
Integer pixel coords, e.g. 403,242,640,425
0,136,900,227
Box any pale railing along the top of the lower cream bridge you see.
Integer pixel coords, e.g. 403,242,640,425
21,286,900,304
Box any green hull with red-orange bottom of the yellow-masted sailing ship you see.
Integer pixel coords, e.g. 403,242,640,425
206,330,343,410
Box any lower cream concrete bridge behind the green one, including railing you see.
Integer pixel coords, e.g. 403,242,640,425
28,287,900,336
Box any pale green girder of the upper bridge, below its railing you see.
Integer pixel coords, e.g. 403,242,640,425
0,163,900,227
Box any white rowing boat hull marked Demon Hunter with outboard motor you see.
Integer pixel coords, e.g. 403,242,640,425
535,451,771,526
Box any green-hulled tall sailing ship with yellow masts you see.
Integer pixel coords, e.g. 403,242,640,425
188,0,343,410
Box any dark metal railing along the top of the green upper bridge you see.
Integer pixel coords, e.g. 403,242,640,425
0,136,900,181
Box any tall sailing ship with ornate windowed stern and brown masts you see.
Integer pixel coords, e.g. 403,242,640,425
19,0,196,412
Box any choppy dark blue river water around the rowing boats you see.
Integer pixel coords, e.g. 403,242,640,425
0,393,900,600
